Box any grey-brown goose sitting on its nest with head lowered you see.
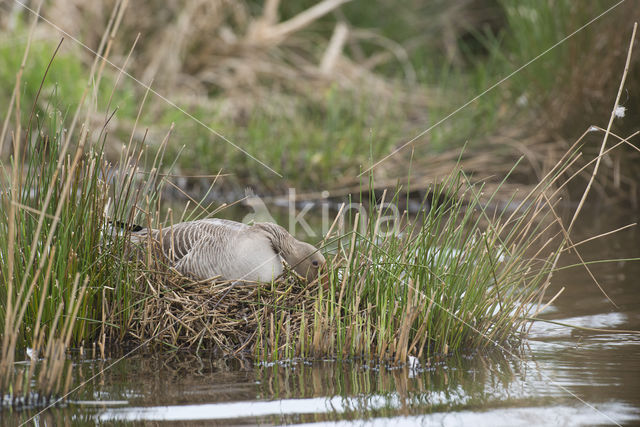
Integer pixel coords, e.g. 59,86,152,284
131,218,325,282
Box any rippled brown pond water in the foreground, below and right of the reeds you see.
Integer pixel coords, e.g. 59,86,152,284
0,212,640,426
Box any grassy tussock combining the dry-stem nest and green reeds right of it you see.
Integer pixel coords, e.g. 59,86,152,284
129,155,571,364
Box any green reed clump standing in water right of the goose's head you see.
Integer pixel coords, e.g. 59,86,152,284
254,165,563,363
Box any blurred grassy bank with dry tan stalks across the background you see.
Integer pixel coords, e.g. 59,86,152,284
0,0,640,204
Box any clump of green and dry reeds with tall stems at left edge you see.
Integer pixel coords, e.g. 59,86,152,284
0,0,169,405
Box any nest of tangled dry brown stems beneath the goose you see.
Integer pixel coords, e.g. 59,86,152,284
129,269,319,355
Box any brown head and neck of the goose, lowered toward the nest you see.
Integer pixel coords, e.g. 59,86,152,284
254,222,326,282
